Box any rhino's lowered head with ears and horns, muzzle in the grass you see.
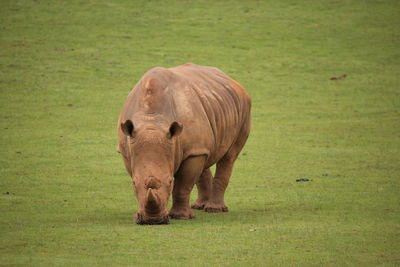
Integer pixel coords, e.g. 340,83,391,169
120,120,182,224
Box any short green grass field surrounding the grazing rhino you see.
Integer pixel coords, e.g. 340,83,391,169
0,0,400,266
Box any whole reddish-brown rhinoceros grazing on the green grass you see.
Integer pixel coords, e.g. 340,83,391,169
118,63,251,224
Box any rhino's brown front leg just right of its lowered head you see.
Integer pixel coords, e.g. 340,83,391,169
169,156,205,219
